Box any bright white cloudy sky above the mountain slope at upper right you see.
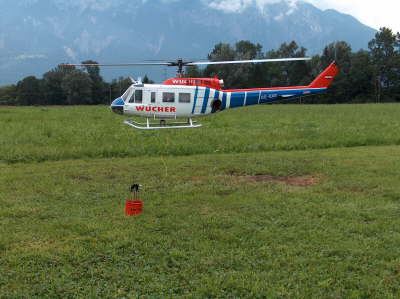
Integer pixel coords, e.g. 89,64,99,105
306,0,400,32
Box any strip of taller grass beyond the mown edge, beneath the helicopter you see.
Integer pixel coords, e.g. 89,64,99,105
0,104,400,163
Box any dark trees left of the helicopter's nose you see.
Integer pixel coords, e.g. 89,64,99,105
0,60,152,106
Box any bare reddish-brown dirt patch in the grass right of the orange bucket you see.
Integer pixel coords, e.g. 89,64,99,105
237,174,319,187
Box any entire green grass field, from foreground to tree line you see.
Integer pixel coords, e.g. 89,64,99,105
0,104,400,298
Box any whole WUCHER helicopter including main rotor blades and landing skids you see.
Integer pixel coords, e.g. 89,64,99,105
65,57,339,130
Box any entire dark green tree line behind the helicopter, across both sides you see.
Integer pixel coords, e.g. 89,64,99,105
0,27,400,105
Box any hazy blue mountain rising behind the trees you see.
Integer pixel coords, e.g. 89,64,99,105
0,0,376,86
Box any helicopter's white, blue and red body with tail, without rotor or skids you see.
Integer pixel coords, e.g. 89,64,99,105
111,63,338,127
